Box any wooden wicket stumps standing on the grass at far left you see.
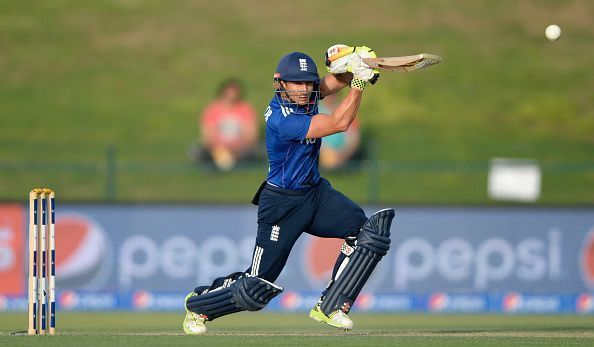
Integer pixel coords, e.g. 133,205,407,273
27,188,56,335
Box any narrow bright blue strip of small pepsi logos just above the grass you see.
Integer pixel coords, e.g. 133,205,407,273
0,290,594,314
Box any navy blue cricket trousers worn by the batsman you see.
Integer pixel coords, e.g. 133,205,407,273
246,178,367,282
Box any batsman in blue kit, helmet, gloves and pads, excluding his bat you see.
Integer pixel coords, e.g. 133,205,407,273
183,45,394,335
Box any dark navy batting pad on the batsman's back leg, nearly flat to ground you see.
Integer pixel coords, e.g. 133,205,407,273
186,276,283,321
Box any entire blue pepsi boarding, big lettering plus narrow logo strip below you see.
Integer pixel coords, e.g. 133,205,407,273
0,204,594,314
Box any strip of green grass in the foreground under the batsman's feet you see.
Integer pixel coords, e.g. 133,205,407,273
0,312,594,347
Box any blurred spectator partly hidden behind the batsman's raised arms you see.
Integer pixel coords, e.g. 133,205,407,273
318,94,361,170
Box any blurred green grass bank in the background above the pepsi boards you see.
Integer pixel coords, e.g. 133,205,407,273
0,0,594,204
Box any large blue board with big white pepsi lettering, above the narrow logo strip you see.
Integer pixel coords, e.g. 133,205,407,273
44,205,594,298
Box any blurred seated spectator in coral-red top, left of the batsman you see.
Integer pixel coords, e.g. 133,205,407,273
192,79,258,170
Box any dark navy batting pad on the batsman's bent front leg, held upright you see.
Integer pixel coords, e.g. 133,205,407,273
320,209,394,316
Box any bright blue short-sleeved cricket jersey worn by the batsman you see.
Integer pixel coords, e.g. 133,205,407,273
264,97,322,190
